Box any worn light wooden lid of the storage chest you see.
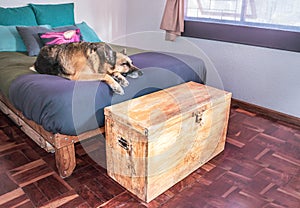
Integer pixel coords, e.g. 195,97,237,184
104,82,231,135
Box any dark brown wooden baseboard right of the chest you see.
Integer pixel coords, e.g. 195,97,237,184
231,98,300,128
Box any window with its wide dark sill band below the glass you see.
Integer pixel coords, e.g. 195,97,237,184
183,0,300,51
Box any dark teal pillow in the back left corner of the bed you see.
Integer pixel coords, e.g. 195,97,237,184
0,6,37,26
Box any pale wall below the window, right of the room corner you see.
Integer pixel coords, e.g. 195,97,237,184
121,0,300,117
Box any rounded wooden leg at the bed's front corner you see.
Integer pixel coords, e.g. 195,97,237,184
55,144,76,178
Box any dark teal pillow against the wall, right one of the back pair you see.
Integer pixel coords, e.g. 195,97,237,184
29,3,75,27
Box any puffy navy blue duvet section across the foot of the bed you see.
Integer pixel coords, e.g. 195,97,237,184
9,52,206,135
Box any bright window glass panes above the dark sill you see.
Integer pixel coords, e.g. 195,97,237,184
185,0,300,31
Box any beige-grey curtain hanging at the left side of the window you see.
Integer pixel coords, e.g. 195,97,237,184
160,0,184,41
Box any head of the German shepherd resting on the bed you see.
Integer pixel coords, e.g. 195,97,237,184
114,50,143,78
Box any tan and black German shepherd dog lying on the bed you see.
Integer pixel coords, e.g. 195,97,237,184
31,42,143,95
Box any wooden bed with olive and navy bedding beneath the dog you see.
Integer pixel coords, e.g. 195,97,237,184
0,2,206,177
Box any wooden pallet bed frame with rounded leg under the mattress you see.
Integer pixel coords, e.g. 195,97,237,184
0,92,105,178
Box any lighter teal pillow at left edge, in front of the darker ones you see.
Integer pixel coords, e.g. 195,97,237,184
0,25,26,52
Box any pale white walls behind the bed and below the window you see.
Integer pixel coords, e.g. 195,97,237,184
0,0,300,117
